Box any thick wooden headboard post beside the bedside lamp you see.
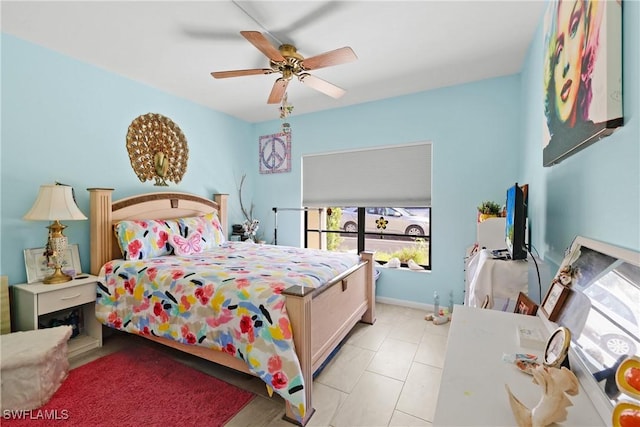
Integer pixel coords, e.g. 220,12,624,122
87,188,113,276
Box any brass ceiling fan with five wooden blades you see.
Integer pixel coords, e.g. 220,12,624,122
211,31,358,104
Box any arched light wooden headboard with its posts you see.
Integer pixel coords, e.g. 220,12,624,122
87,188,229,275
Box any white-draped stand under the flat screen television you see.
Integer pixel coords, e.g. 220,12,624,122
464,249,529,311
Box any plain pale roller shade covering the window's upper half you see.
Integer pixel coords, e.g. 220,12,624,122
302,142,431,207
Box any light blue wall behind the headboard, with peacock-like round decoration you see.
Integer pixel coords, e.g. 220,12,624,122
0,34,253,284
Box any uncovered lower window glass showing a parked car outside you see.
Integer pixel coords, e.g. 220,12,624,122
305,207,431,270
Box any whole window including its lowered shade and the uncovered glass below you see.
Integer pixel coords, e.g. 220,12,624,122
302,142,432,269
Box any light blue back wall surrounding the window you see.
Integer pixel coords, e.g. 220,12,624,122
253,76,520,304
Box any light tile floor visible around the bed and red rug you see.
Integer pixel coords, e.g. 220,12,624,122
71,303,449,427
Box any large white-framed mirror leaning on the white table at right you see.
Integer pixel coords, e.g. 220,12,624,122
554,237,640,410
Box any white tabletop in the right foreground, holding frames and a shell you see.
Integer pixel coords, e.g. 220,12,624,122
433,305,610,427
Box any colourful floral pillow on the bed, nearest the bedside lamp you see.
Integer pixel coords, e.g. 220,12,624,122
114,219,178,260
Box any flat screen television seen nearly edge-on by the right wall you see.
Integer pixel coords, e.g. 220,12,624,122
505,182,527,260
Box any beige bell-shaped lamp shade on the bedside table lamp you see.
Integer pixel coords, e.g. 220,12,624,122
23,184,87,221
